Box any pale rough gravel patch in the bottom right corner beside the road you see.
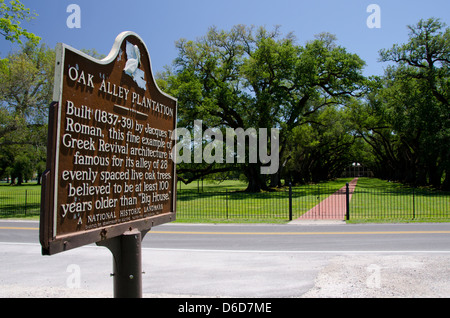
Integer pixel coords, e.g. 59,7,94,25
302,254,450,298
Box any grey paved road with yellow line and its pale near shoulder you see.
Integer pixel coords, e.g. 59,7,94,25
0,221,450,297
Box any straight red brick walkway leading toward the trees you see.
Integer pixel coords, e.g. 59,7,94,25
298,178,358,220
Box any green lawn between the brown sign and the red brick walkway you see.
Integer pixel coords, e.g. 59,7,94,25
177,179,351,223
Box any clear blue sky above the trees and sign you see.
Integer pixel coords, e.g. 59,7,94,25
0,0,450,75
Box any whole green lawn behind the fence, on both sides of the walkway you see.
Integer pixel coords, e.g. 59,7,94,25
0,178,450,223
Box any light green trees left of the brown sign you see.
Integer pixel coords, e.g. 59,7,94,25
0,0,48,184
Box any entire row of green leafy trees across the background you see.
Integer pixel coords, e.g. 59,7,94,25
0,1,450,191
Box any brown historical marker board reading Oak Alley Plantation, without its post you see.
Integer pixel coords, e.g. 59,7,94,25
40,32,177,255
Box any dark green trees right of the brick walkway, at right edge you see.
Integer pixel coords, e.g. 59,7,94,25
349,19,450,190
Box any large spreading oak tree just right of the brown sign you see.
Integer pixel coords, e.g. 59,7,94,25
165,25,364,191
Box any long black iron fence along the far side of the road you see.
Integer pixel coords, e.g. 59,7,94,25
0,184,450,222
